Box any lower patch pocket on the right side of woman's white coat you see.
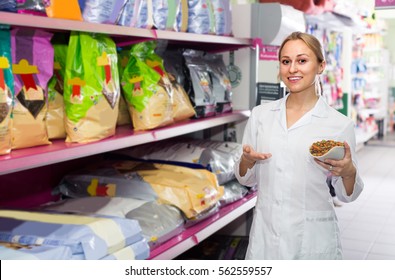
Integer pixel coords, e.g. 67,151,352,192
300,211,341,260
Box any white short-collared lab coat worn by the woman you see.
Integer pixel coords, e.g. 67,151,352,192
235,95,363,259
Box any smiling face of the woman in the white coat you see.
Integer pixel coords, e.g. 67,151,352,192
280,40,325,94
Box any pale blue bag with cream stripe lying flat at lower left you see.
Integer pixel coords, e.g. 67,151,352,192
0,210,147,260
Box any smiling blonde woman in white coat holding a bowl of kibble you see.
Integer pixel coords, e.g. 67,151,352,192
235,32,363,259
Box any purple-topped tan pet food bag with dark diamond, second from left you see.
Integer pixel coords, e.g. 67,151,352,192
11,28,54,149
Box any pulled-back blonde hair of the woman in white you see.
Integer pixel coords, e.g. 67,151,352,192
278,31,325,95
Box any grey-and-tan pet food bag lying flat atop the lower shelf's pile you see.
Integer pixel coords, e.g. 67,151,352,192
55,160,224,218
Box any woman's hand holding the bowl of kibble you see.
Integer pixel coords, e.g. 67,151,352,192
314,142,356,178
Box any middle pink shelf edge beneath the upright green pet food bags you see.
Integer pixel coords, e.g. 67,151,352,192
0,110,250,175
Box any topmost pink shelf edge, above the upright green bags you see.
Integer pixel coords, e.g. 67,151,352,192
0,12,251,52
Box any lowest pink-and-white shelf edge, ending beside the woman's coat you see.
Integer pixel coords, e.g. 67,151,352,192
149,192,257,260
